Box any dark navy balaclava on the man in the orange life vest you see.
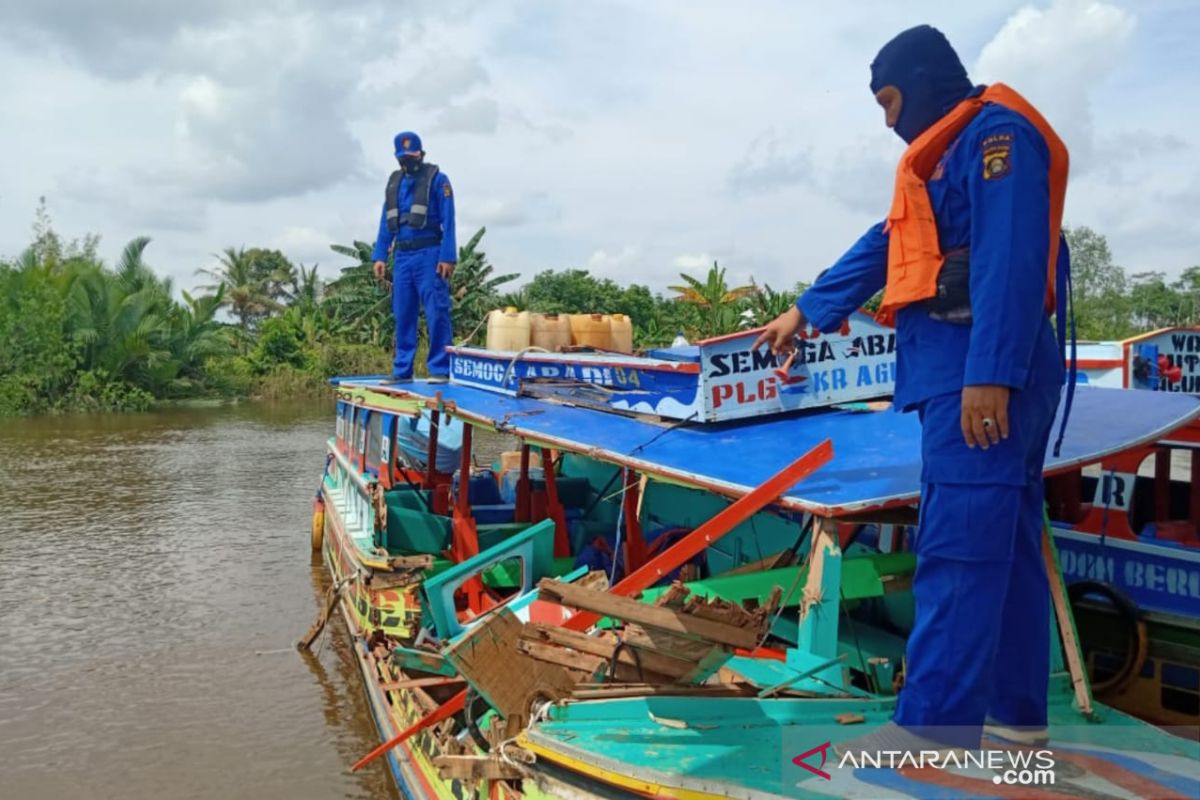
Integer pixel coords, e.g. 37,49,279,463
871,25,971,144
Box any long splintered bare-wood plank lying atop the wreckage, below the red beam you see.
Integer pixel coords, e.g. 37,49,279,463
538,578,761,648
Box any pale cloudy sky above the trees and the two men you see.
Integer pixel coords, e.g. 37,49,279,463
0,0,1200,297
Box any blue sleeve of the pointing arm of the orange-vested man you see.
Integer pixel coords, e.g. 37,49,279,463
796,222,888,332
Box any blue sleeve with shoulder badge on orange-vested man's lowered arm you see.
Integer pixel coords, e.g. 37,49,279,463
962,121,1050,389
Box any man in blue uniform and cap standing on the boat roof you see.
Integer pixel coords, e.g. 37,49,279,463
372,131,458,384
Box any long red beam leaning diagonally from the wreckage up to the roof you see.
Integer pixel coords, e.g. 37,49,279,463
563,439,833,631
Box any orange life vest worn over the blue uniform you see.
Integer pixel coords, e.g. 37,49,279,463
878,83,1068,324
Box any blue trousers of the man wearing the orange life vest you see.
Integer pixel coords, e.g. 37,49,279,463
895,386,1060,748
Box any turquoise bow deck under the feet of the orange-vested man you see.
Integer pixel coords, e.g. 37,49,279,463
527,674,1200,800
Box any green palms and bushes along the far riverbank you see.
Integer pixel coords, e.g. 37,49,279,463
0,200,1200,416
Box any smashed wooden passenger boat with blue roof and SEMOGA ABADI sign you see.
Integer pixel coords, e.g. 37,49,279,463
306,317,1200,799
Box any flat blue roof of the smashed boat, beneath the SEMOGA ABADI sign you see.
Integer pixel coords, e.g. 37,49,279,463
337,378,1200,516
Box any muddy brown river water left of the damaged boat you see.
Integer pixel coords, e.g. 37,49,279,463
0,403,477,799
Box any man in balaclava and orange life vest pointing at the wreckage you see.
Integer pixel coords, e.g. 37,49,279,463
758,25,1067,753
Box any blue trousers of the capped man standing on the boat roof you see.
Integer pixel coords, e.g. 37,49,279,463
391,246,452,378
